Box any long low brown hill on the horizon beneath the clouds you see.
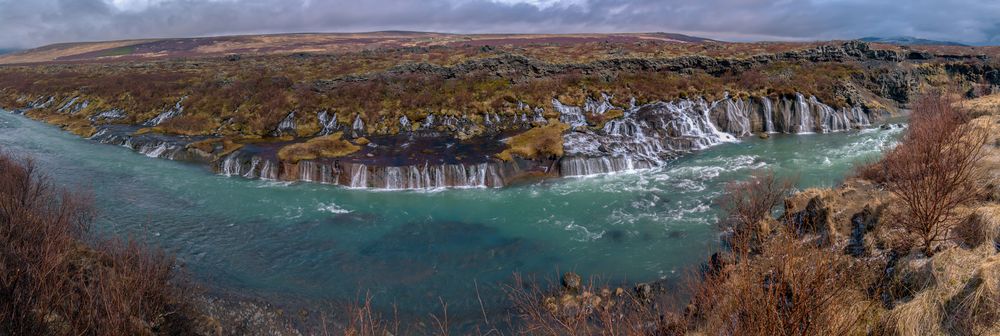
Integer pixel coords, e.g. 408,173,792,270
0,31,712,64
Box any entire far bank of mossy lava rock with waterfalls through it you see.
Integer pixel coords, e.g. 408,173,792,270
0,41,1000,189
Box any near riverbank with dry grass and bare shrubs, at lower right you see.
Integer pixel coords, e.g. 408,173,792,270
509,92,1000,336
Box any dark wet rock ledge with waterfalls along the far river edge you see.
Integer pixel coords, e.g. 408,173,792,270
5,86,882,190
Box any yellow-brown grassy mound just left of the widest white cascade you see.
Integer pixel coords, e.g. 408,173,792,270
497,120,569,161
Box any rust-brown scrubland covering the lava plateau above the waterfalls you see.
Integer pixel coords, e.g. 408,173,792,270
0,40,1000,146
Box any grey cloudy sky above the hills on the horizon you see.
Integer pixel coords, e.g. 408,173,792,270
0,0,1000,48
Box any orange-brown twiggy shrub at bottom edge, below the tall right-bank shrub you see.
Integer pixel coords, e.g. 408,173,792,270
687,234,876,335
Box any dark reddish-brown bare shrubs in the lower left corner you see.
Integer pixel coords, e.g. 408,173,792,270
0,151,189,335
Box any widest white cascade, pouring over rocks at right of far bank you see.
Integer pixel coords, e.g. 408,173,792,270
553,94,872,176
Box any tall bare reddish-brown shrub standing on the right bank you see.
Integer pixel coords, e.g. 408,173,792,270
882,93,989,255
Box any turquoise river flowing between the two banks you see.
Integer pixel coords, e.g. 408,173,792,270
0,113,899,323
